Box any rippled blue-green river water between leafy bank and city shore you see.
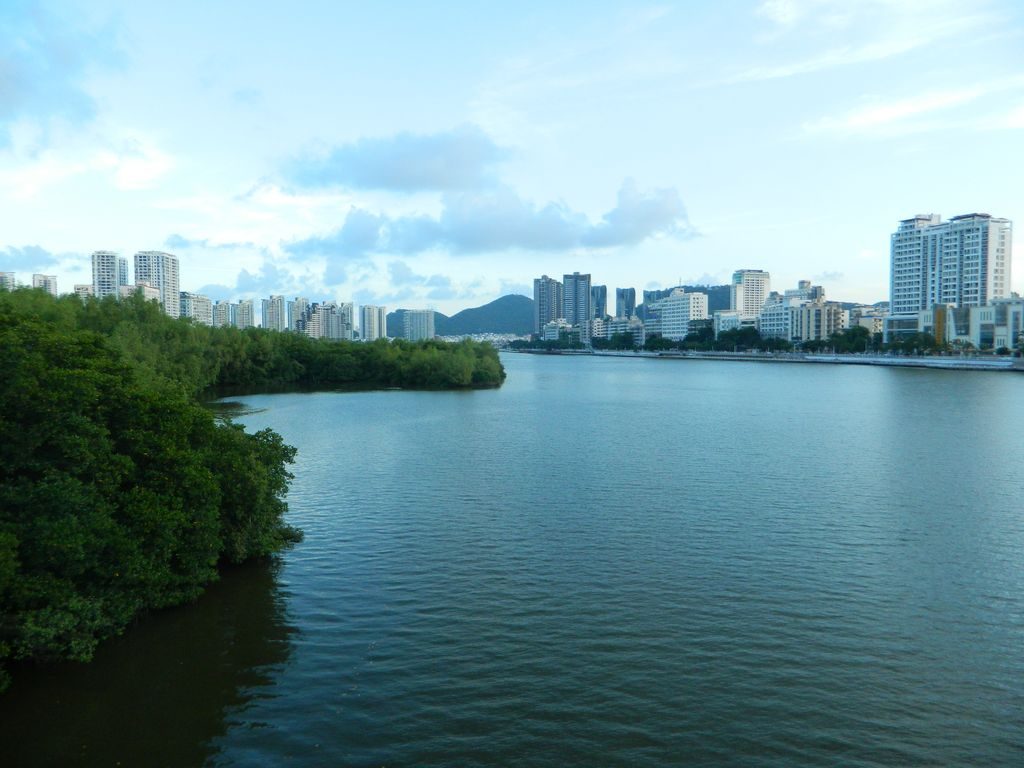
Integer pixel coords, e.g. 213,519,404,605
0,355,1024,766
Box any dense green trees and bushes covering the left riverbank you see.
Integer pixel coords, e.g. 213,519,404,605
0,290,505,689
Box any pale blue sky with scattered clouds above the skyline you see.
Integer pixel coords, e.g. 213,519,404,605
0,0,1024,314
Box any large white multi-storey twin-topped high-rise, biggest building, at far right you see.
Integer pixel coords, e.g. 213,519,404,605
889,213,1013,317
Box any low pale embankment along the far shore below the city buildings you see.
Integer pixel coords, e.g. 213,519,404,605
508,349,1024,373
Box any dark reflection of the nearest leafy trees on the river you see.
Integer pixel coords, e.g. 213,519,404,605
0,560,294,766
